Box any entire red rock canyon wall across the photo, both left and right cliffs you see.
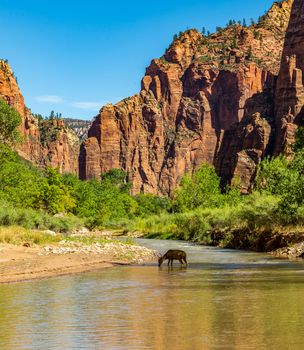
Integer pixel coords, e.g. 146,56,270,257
0,0,304,196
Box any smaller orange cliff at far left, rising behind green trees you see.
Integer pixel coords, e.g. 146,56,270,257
0,60,79,174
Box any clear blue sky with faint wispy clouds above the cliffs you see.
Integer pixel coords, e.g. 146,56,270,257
0,0,273,119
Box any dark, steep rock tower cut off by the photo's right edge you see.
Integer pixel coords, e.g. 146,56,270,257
275,0,304,155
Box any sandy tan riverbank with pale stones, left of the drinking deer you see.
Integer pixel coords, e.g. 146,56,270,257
0,242,156,283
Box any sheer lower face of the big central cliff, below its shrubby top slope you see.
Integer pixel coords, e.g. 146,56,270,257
80,60,273,195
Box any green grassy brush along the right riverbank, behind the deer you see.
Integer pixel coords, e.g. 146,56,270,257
125,193,281,243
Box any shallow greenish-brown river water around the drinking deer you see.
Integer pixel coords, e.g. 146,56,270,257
0,240,304,350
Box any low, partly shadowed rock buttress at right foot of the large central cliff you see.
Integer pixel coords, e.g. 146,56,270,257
216,92,274,193
